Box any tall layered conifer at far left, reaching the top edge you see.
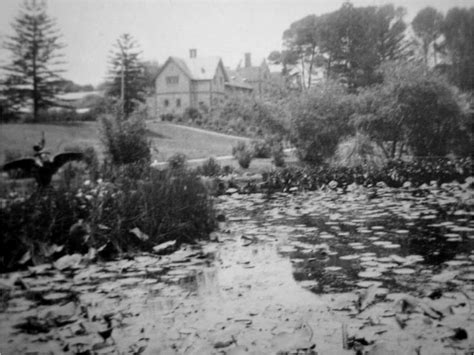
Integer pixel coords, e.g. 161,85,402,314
2,0,64,121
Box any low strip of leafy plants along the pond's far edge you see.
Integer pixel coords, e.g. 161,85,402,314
264,158,472,191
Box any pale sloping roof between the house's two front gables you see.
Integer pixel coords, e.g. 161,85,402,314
157,57,229,81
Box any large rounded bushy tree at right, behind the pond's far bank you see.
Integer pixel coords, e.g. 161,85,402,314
352,63,463,158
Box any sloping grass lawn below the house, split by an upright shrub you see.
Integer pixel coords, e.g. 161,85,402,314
0,121,250,162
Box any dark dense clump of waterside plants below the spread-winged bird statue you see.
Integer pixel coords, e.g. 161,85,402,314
0,163,214,272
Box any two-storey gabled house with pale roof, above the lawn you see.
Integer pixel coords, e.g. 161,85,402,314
151,49,252,115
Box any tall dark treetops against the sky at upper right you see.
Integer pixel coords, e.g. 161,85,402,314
269,3,474,90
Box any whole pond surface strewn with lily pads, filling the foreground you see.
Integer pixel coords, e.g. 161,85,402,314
0,185,474,354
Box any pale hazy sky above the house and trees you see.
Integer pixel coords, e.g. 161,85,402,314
0,0,474,85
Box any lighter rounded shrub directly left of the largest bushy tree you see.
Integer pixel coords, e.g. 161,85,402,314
291,83,355,164
